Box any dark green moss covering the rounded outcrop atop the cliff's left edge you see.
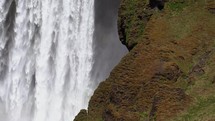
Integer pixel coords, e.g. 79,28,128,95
119,0,150,47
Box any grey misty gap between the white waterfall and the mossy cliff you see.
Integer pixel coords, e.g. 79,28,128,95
92,0,128,86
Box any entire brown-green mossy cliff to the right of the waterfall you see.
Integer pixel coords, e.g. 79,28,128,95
75,0,215,121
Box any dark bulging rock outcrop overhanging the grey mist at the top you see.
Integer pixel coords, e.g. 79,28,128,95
118,0,153,50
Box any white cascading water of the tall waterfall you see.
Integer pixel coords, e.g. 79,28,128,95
0,0,94,121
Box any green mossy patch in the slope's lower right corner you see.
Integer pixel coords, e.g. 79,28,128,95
172,54,215,121
